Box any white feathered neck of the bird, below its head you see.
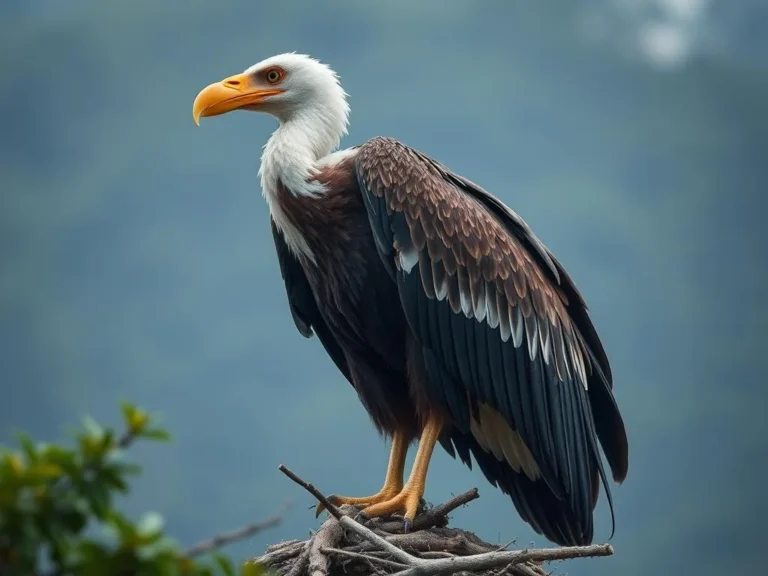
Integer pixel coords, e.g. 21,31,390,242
259,99,348,260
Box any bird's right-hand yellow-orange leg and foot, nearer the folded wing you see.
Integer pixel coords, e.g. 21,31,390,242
360,416,443,532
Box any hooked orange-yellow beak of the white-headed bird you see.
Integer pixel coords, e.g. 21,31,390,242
192,74,283,126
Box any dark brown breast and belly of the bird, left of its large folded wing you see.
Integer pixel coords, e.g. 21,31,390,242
272,151,419,440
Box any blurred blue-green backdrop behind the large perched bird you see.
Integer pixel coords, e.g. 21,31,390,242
0,0,768,576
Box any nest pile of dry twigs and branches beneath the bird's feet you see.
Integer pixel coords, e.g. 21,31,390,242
252,466,613,576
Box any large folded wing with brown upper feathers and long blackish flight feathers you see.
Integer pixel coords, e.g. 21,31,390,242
356,138,627,544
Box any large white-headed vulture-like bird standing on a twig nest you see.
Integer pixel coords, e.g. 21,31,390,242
193,52,629,546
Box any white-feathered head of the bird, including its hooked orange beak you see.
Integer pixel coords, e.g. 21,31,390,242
192,53,349,160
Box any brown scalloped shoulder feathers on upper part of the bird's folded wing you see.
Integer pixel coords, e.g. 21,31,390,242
354,137,610,379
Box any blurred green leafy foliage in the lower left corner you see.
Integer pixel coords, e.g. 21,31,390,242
0,403,264,576
